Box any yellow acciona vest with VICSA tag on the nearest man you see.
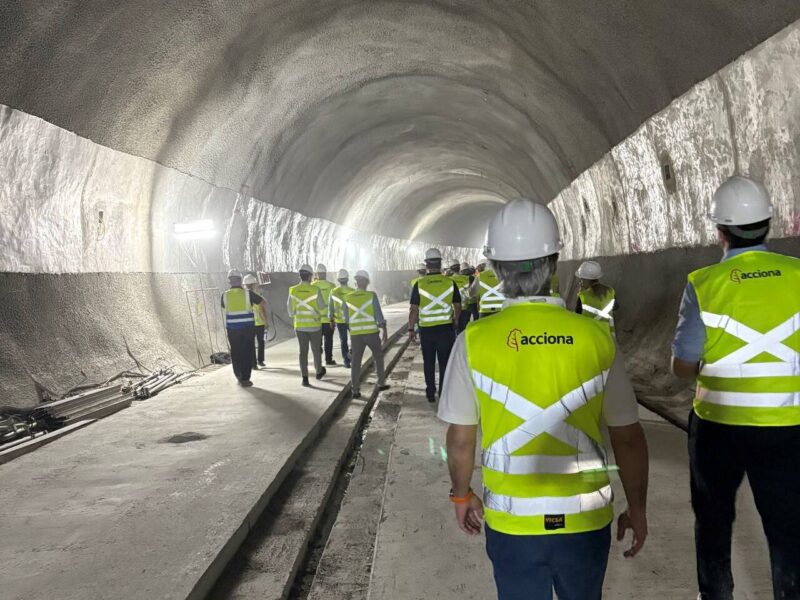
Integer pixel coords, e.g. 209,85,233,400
466,303,615,535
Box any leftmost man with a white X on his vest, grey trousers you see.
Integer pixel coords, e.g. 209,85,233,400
286,265,327,387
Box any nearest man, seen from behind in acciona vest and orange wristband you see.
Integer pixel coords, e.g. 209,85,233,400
438,199,648,600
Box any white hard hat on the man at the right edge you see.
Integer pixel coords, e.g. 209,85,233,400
708,175,772,225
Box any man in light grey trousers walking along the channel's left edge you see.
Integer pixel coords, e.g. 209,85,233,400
344,271,389,398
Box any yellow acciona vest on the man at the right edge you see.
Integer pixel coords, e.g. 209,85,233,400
689,251,800,427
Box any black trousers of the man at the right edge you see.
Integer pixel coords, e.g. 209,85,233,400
689,411,800,600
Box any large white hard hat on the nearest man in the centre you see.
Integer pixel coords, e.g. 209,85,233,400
483,198,564,261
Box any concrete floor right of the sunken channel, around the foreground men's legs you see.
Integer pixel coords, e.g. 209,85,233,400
369,352,772,600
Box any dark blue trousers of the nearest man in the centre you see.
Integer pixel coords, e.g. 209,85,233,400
486,525,611,600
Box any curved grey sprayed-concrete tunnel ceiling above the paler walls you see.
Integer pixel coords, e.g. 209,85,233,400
0,0,800,245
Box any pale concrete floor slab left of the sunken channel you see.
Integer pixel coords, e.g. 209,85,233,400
0,307,405,600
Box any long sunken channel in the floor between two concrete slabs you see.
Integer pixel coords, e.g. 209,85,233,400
208,336,408,600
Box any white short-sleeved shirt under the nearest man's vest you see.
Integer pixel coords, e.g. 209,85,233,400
438,298,639,427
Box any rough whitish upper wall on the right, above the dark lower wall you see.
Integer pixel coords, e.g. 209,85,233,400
550,22,800,259
